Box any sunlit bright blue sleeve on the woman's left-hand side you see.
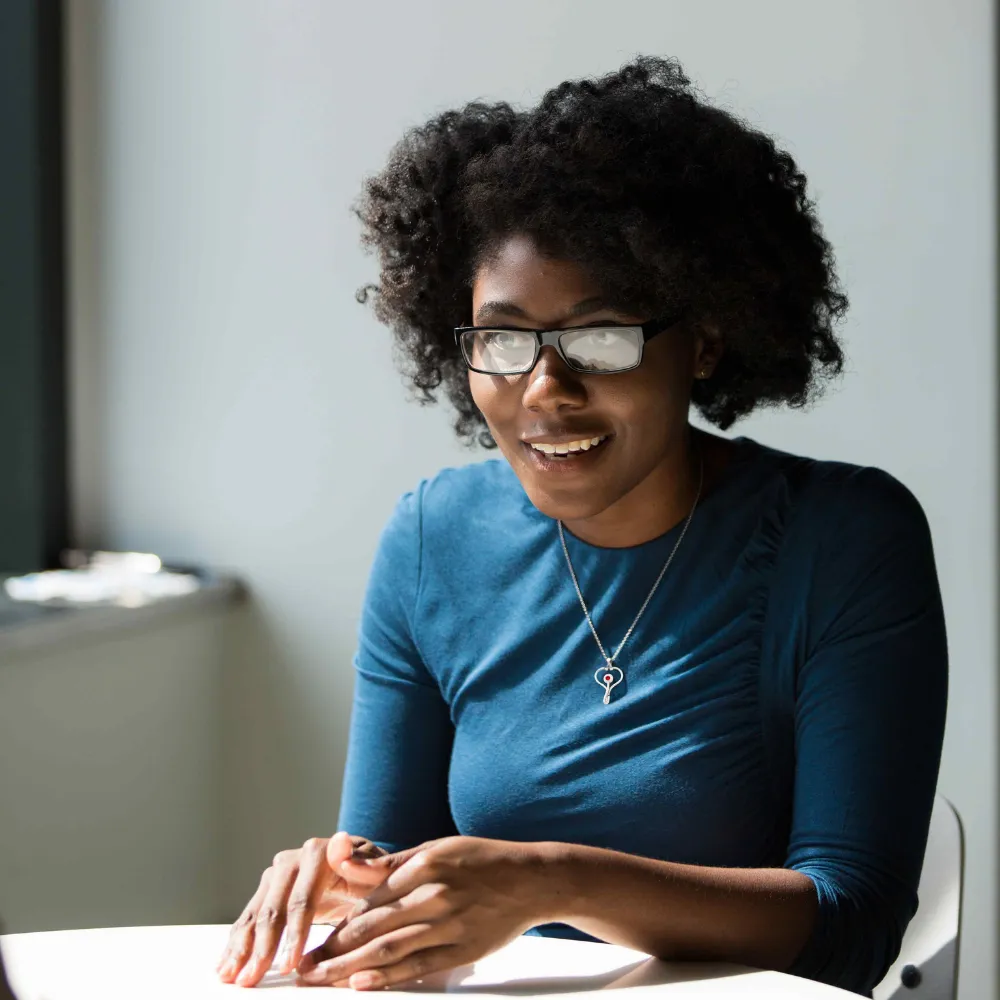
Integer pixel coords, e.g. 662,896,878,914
337,490,457,851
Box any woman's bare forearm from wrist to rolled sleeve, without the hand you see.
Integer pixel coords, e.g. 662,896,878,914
538,843,818,970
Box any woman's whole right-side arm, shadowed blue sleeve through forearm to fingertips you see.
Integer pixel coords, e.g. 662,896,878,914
310,472,947,992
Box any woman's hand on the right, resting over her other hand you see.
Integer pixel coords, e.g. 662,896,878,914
298,837,545,989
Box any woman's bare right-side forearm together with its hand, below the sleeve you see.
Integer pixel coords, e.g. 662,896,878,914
299,837,816,989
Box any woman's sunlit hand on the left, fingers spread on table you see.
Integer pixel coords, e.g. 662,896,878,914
216,833,388,986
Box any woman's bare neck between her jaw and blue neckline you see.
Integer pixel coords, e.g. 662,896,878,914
563,425,708,549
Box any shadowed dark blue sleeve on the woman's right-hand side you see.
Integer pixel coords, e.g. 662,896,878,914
778,469,947,995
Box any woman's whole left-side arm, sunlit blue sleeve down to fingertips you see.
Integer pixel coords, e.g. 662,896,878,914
221,486,454,1000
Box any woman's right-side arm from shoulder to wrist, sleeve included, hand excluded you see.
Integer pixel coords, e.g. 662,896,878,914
544,469,947,992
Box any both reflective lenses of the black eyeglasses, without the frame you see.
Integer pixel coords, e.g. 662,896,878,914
463,327,642,375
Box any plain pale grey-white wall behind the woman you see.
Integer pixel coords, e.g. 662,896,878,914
70,0,997,1000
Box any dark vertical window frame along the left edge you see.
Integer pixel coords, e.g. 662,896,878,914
0,0,69,573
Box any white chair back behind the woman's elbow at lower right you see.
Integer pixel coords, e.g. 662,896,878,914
872,795,965,1000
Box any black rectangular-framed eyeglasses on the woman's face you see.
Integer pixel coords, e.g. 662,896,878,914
455,315,681,375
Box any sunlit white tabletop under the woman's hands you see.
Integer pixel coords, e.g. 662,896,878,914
0,924,857,1000
